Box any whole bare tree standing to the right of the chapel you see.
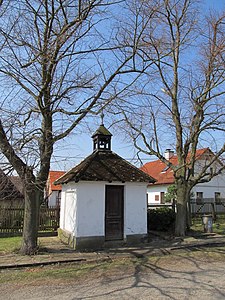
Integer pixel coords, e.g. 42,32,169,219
111,0,225,236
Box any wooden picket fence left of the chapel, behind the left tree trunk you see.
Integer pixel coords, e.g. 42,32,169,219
0,207,59,236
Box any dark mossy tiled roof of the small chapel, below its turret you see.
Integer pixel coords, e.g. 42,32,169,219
55,151,155,184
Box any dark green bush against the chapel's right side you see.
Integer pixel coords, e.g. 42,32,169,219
148,207,176,231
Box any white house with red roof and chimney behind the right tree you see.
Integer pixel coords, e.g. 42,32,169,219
141,148,225,204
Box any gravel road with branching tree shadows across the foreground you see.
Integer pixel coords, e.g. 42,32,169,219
0,249,225,300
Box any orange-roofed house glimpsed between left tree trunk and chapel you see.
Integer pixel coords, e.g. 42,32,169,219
45,171,65,207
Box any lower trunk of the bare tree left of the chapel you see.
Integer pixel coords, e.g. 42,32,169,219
20,174,41,255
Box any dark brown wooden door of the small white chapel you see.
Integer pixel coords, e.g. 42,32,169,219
105,185,124,241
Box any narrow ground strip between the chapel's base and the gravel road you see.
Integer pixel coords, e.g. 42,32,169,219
0,234,225,270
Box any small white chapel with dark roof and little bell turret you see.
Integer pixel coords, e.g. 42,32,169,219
55,125,154,249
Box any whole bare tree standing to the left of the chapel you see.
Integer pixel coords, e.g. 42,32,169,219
0,0,142,254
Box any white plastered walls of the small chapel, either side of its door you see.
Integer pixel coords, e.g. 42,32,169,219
60,182,147,249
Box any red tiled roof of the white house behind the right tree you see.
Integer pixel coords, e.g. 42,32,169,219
141,148,212,185
